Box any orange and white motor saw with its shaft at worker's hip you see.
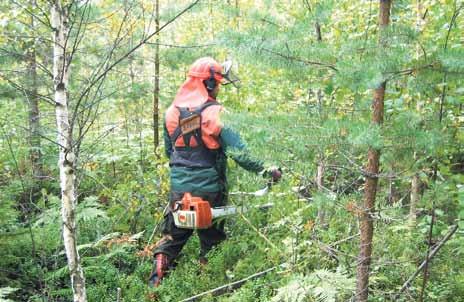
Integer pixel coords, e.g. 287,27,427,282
172,187,273,229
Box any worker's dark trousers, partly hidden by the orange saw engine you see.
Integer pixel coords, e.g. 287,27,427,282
153,192,226,263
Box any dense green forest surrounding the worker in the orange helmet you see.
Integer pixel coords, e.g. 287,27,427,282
0,0,464,301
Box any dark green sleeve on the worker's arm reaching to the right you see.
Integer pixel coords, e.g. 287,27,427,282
219,127,264,173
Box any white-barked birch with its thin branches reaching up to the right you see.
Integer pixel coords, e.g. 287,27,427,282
50,0,199,302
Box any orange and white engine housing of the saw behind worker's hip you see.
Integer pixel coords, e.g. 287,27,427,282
173,193,213,229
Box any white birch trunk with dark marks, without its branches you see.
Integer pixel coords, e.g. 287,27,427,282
51,0,87,302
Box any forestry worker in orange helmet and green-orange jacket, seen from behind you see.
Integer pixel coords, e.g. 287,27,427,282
150,57,282,286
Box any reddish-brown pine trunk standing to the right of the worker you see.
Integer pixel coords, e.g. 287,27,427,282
356,0,391,302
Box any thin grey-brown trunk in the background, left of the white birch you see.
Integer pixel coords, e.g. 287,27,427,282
28,1,43,180
